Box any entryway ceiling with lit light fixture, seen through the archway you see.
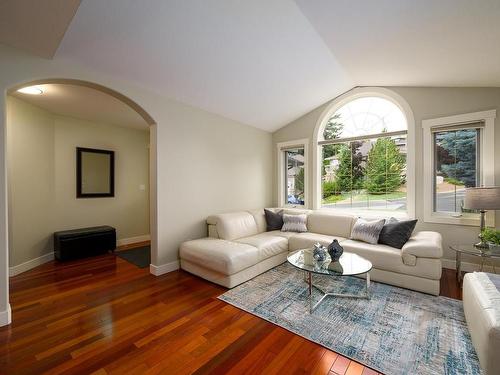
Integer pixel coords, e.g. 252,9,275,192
11,83,149,130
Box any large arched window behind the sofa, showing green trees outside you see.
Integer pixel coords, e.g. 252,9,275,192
316,92,414,216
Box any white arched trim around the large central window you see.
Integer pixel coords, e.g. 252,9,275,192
312,87,415,217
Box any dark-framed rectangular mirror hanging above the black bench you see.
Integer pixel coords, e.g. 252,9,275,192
76,147,115,198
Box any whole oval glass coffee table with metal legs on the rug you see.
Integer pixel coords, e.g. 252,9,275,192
287,249,373,313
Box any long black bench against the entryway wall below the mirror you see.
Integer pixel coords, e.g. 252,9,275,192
54,225,116,260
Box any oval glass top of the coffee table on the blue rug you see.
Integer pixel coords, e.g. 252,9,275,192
287,250,372,276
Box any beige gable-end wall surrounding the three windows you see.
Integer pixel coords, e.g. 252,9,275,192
273,87,500,261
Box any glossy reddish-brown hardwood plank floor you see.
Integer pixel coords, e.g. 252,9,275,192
0,254,461,375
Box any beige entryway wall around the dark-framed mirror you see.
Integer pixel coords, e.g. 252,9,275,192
54,116,149,240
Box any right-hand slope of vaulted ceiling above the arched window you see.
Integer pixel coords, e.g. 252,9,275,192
296,0,500,86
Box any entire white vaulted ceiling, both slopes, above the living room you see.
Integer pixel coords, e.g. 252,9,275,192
0,0,500,131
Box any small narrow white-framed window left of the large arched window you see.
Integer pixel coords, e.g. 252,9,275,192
278,139,308,207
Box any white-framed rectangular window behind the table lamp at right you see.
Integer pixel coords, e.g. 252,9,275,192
422,111,496,225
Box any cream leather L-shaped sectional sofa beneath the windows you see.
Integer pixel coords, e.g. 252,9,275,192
179,209,443,295
